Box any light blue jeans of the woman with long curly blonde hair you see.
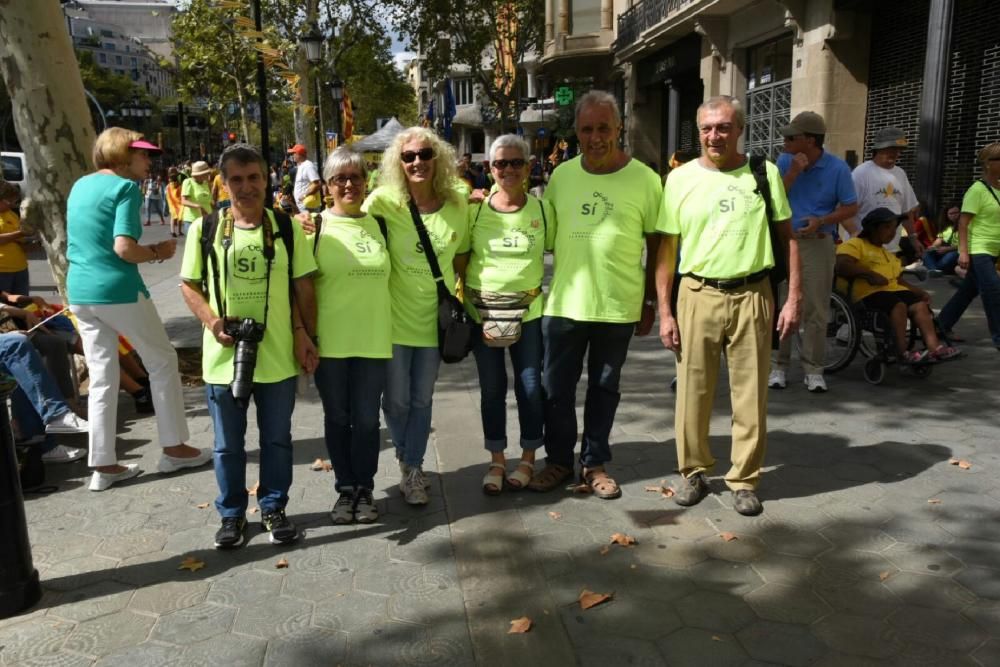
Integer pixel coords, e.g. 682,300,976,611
382,344,441,467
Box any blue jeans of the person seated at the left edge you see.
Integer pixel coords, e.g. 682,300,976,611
0,333,69,451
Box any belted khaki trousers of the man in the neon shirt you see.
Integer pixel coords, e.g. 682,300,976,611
674,276,774,491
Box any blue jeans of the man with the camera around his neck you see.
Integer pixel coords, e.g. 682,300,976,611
205,377,296,518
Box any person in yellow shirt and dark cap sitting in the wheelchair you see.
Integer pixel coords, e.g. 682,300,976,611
835,208,961,364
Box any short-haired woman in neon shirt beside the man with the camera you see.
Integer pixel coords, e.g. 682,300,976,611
312,147,392,524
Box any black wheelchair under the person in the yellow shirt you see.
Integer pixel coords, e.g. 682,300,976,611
823,285,950,385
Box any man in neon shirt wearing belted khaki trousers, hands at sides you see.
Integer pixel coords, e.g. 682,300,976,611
656,96,801,516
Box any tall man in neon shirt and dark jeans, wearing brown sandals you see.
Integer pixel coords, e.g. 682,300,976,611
529,90,662,498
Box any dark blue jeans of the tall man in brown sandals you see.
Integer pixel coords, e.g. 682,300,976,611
542,317,635,468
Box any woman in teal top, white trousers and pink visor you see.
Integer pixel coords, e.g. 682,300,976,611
66,127,212,491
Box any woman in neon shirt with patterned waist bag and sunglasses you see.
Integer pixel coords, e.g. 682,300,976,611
459,134,555,495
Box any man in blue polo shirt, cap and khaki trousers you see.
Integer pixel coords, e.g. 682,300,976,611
767,111,858,393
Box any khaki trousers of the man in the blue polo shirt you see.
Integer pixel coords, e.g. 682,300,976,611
772,235,837,375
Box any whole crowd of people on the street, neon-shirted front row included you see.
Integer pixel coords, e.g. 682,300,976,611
0,86,1000,548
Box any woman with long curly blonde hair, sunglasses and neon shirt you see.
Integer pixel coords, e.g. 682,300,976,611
364,127,468,505
